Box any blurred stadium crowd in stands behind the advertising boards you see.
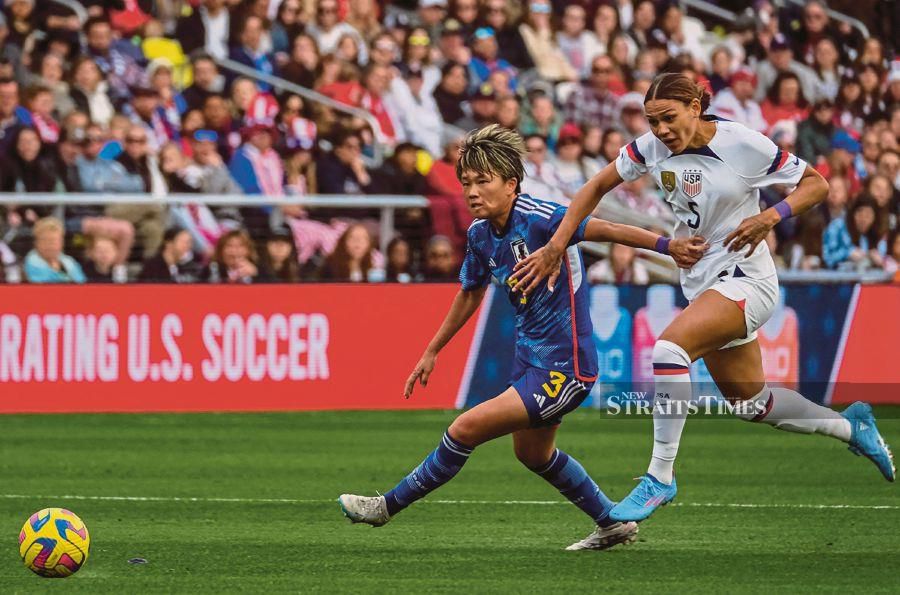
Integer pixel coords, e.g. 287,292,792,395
0,0,900,283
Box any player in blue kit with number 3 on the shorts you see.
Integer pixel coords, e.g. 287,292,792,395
339,125,706,550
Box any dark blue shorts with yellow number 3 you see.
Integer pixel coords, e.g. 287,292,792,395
511,361,594,428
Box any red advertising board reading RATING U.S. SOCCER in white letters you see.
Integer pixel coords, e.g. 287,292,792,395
0,285,475,413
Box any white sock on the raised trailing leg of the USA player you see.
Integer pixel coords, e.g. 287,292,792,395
735,386,850,442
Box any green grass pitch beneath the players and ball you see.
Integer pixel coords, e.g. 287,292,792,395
0,408,900,593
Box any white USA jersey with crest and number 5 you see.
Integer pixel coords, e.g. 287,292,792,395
616,116,806,300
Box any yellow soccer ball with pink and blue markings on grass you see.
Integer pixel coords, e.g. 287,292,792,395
19,508,91,578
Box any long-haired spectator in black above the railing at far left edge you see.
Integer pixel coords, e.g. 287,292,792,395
0,128,56,194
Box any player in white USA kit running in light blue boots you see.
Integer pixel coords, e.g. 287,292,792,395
515,73,895,521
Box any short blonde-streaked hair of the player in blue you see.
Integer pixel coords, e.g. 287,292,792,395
456,124,525,192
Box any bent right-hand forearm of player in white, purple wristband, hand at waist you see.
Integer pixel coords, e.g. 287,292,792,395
724,165,828,254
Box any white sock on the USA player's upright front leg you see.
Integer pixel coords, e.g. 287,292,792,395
647,340,693,483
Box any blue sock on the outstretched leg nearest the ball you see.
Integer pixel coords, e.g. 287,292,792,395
384,432,473,516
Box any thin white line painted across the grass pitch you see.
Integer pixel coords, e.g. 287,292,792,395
0,494,900,510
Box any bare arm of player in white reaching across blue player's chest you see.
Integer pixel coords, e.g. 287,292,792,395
511,162,622,295
